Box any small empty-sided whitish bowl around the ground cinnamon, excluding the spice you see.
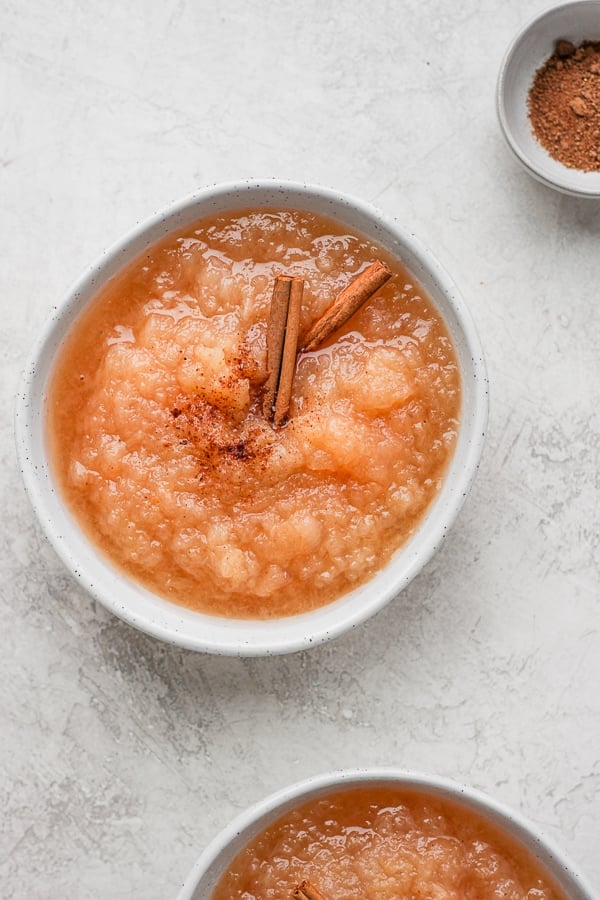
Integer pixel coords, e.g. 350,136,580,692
496,0,600,199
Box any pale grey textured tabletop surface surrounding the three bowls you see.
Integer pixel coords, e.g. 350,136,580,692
0,0,600,900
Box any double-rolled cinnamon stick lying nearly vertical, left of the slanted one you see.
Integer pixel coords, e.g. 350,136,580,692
263,275,304,425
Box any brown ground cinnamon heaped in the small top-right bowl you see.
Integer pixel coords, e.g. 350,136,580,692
528,40,600,172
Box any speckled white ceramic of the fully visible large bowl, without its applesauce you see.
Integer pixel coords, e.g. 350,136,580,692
16,181,488,656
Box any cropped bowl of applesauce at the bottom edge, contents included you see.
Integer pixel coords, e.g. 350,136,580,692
178,769,592,900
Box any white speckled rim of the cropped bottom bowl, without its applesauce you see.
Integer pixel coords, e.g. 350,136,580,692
177,769,593,900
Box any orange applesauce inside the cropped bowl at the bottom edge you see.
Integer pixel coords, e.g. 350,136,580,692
211,787,567,900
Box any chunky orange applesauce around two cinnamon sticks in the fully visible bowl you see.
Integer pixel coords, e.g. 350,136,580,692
47,209,460,618
